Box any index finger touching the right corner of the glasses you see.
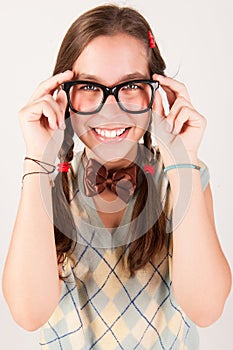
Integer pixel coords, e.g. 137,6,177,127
153,74,190,103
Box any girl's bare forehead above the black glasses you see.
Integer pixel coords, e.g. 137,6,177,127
73,34,149,84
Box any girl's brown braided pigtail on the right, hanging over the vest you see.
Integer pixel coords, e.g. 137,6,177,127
128,127,166,275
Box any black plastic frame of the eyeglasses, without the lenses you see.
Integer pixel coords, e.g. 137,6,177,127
61,79,159,115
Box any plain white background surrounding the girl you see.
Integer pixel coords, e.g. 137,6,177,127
0,0,233,350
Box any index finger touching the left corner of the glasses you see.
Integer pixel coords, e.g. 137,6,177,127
30,70,74,101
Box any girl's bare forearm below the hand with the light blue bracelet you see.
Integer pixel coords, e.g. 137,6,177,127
168,169,231,326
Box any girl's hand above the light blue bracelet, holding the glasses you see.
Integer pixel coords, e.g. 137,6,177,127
153,74,206,165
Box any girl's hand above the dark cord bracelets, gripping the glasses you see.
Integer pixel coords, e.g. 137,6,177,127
19,71,73,162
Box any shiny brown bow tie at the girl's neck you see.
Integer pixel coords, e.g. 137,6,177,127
84,159,137,203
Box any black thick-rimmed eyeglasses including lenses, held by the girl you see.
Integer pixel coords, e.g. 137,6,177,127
62,79,159,115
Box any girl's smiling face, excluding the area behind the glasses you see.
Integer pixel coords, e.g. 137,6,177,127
71,34,151,167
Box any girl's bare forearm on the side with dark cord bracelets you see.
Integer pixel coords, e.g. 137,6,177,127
3,164,59,329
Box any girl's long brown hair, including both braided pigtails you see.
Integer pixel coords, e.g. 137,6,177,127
53,5,170,274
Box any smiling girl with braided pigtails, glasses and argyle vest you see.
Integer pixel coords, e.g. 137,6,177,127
3,5,231,350
